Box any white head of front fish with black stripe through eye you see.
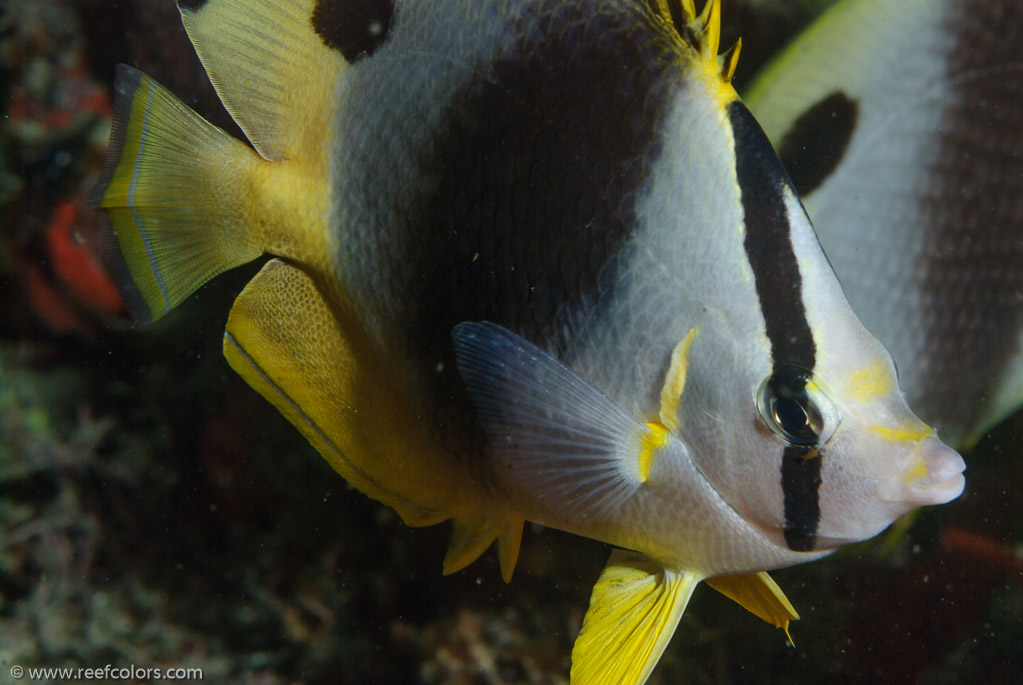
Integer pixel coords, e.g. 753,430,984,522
677,192,965,552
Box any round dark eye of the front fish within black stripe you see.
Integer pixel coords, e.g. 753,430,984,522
757,366,841,447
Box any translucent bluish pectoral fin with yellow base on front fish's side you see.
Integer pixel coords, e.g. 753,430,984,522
452,322,684,522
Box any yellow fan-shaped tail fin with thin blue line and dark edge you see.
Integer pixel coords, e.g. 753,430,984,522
93,65,263,321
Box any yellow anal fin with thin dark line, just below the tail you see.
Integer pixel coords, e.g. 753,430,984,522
224,260,448,526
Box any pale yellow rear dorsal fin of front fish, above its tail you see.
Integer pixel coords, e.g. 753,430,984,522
179,0,347,164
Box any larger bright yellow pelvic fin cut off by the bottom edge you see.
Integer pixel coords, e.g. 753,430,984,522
572,550,701,685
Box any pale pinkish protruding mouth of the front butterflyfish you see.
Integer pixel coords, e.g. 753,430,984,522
878,436,966,507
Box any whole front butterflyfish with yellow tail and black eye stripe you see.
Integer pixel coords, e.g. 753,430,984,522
96,0,965,683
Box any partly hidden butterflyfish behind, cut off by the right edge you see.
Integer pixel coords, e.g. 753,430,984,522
745,0,1023,448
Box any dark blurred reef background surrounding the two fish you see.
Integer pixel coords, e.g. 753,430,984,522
0,0,1023,684
